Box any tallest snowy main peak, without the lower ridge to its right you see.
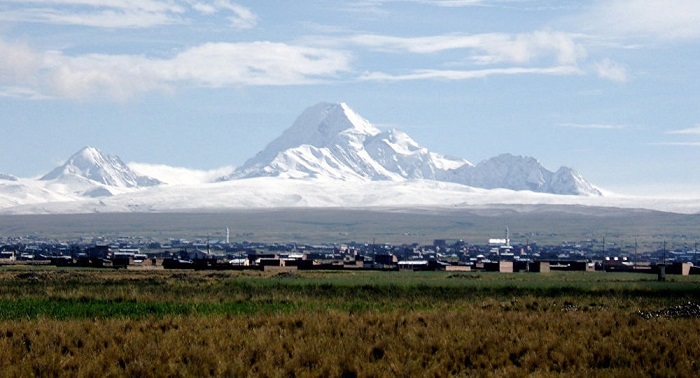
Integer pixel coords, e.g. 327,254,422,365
222,103,469,181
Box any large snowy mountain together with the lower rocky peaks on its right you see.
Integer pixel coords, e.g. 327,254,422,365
222,103,601,196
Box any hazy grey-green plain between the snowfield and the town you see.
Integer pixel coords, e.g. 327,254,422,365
0,205,700,248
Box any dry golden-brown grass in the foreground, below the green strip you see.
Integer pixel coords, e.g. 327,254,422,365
0,303,700,377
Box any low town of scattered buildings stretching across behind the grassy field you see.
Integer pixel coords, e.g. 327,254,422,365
0,228,700,275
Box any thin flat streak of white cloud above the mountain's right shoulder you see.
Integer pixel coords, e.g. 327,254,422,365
360,66,582,81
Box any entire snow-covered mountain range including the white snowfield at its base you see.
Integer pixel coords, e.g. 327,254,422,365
0,103,644,214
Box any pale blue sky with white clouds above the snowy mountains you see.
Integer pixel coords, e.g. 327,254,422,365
0,0,700,194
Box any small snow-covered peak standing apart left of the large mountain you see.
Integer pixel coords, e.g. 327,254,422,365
40,147,161,190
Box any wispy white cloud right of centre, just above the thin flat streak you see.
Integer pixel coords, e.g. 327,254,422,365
350,31,586,64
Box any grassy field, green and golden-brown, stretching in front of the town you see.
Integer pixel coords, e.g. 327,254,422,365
0,267,700,377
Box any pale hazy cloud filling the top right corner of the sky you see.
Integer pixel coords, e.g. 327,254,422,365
581,0,700,40
